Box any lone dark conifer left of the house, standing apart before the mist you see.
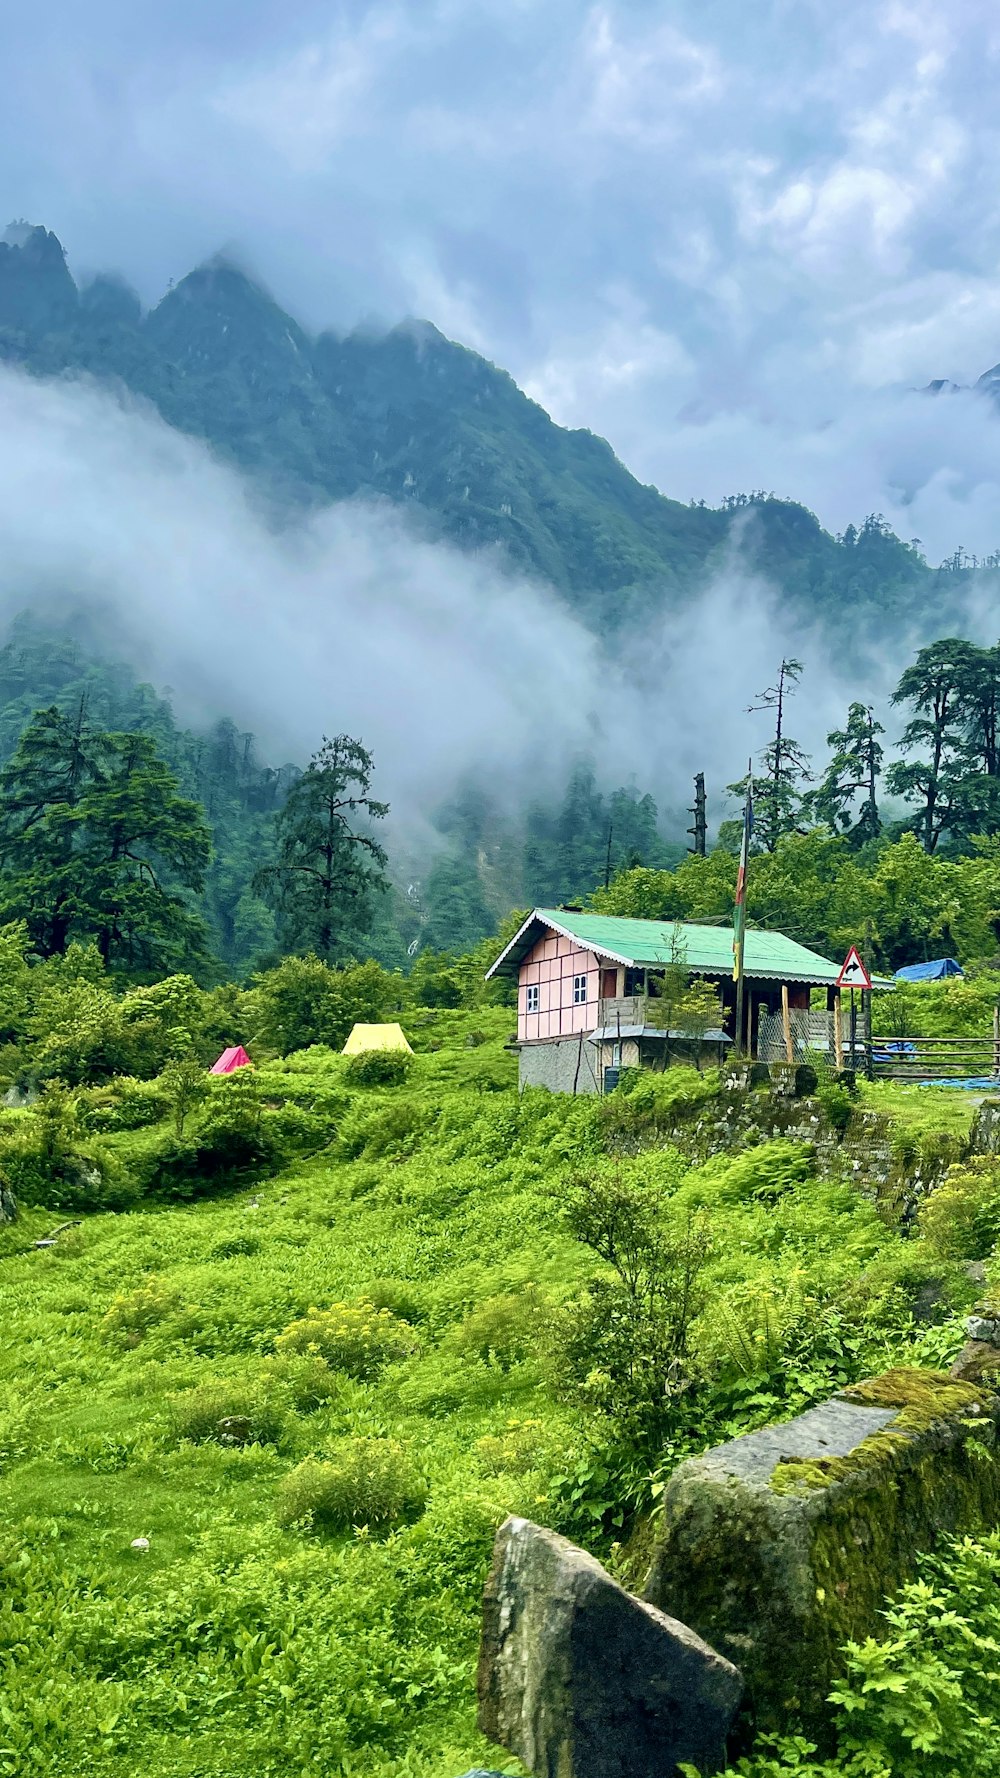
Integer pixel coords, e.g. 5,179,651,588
254,734,390,962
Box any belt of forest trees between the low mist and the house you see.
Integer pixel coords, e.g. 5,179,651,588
0,617,1000,992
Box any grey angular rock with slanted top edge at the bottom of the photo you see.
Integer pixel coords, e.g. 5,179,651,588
479,1518,742,1778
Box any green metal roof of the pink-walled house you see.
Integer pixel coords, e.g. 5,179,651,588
489,907,840,987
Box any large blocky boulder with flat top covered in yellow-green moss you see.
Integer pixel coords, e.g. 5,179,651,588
646,1371,1000,1739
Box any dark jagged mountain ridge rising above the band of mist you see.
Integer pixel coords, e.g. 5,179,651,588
0,222,932,633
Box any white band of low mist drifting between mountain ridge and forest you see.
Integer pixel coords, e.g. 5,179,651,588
0,360,988,846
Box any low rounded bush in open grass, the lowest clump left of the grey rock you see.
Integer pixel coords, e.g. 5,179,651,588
278,1438,427,1531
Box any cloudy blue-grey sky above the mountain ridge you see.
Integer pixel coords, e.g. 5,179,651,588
0,0,1000,557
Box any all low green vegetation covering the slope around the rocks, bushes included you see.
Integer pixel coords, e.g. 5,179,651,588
0,962,1000,1778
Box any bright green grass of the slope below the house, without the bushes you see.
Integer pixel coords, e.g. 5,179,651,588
0,1038,982,1778
